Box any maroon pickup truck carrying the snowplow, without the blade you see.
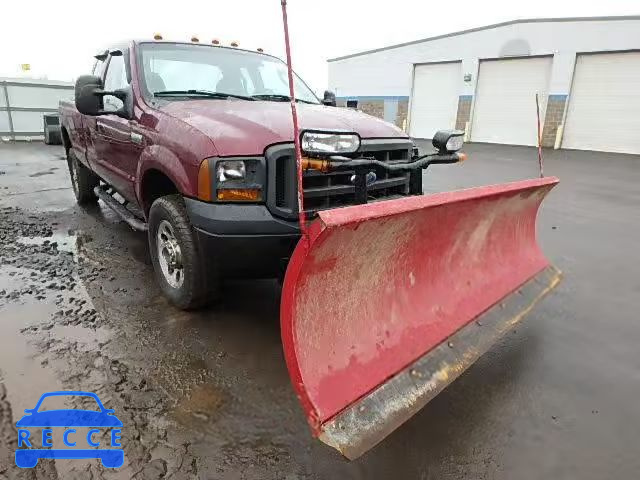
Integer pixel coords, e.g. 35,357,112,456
60,40,461,309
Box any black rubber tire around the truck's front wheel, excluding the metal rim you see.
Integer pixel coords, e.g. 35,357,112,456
148,195,218,310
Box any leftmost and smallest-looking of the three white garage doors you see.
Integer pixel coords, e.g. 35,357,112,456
409,62,462,138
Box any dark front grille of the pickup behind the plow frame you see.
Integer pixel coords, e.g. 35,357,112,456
267,139,412,218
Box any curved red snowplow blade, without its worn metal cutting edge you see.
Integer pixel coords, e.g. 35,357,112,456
280,178,558,433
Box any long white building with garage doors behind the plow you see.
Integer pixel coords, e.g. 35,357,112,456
329,16,640,154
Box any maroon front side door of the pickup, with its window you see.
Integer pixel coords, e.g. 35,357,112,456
94,51,142,202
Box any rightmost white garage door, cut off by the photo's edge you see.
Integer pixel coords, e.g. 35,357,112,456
562,52,640,153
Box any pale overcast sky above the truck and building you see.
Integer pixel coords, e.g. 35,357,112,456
0,0,640,91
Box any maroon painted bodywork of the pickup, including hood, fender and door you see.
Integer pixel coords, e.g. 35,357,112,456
60,41,407,212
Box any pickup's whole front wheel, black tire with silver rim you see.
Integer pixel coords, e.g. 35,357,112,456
149,195,216,310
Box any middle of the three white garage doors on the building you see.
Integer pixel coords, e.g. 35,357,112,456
471,57,552,145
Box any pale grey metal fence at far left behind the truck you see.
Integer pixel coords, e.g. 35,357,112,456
0,78,74,140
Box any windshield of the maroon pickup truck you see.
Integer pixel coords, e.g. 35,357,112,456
140,43,319,103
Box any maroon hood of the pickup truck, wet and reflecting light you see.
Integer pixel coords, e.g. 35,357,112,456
160,99,407,156
